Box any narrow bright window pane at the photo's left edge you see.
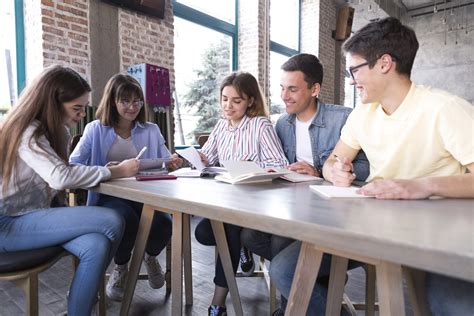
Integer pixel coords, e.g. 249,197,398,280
0,1,16,117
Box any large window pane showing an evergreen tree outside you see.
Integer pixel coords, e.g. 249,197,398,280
174,17,232,146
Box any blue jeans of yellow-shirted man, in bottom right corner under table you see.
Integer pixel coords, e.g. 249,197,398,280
425,273,474,316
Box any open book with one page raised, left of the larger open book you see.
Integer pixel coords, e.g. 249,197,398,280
170,146,226,178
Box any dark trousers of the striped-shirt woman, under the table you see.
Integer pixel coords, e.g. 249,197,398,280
194,218,242,288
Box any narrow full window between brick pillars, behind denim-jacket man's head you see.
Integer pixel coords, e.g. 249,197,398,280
269,0,300,122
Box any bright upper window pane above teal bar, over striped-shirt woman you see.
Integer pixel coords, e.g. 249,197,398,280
177,0,235,24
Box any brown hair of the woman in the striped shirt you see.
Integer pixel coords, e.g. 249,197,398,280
219,71,268,117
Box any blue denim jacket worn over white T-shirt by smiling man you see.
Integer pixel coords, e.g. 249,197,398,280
276,100,369,181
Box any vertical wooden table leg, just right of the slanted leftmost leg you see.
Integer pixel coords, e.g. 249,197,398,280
171,212,183,315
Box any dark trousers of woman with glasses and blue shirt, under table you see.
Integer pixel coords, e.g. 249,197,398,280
97,194,173,265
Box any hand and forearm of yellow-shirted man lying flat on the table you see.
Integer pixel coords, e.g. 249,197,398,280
358,179,431,200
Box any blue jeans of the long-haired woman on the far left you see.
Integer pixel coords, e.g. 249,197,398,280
0,206,124,316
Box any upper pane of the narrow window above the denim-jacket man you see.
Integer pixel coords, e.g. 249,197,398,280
270,0,300,50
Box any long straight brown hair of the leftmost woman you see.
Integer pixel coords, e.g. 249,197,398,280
0,65,91,190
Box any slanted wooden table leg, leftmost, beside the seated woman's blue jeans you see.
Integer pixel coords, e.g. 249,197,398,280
120,204,155,316
